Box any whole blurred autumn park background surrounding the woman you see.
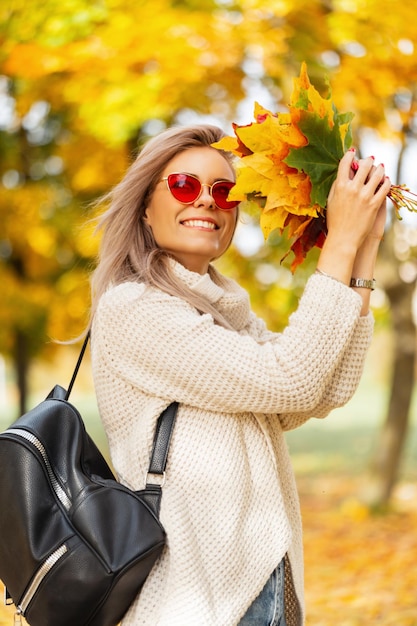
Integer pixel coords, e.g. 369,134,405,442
0,0,417,626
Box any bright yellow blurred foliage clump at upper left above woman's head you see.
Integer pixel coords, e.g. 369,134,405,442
2,0,243,144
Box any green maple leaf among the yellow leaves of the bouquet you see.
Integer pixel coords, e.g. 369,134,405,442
284,106,352,208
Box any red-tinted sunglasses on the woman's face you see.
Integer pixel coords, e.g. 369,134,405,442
160,172,240,211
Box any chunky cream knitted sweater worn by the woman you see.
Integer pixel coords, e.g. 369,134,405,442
92,263,373,626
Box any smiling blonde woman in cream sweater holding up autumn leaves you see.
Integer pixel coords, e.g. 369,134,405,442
92,126,390,626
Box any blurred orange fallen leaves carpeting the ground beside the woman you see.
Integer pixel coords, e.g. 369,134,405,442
0,474,417,626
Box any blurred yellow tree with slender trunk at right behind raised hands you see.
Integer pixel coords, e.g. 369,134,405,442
228,0,417,505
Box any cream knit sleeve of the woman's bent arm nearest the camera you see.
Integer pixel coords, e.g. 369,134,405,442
93,275,368,414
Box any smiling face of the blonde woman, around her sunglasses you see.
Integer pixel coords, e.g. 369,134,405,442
145,147,237,274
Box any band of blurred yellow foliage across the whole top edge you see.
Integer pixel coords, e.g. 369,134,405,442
2,0,416,142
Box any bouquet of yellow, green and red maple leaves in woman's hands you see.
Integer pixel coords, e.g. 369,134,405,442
213,63,417,272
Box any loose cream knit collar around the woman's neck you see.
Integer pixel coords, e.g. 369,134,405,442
171,260,250,330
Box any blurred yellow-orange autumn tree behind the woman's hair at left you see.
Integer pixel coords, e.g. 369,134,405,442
0,0,247,411
